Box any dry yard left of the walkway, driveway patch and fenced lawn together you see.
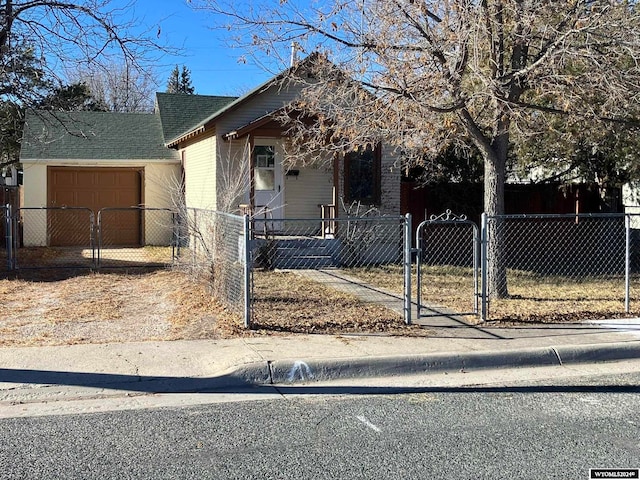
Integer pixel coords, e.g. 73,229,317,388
0,270,420,346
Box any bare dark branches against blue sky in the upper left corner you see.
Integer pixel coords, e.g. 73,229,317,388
0,0,166,107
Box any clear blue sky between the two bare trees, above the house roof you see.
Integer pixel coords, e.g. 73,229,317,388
124,0,271,95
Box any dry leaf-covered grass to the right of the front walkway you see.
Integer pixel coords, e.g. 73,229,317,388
350,266,640,325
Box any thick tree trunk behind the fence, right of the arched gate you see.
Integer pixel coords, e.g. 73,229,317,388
484,133,509,298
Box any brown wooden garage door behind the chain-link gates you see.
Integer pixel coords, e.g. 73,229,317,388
47,167,142,246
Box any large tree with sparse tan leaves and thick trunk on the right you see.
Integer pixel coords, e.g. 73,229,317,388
195,0,640,296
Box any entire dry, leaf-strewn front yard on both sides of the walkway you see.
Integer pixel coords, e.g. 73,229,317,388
0,260,640,346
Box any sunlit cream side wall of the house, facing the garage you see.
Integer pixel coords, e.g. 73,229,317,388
181,136,216,210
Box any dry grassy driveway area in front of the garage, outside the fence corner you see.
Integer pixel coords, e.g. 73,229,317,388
0,270,241,346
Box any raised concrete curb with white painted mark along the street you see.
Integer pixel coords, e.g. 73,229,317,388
228,341,640,385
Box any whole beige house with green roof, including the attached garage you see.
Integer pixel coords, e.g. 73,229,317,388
20,57,400,245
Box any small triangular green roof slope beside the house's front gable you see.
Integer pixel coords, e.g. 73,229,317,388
156,93,237,143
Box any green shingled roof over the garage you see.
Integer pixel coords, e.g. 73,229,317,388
20,111,178,160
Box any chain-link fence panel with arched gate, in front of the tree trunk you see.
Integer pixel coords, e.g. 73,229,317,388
414,212,640,322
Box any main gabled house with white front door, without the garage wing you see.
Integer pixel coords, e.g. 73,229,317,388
157,56,400,218
